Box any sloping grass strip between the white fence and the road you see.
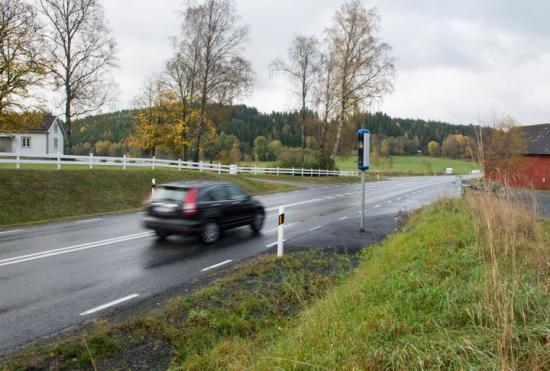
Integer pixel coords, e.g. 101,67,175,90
0,169,296,228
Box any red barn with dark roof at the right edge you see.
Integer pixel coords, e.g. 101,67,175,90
502,124,550,190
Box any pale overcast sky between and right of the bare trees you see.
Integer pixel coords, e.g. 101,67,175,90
100,0,550,124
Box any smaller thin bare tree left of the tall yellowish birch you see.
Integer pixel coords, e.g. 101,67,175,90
270,35,321,150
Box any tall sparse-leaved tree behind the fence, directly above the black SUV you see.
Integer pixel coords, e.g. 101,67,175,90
182,0,252,162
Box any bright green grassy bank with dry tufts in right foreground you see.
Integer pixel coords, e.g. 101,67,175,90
251,195,550,369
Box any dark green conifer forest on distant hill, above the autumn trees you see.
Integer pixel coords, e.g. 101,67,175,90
73,105,474,154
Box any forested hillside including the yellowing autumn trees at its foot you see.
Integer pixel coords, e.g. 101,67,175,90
73,105,474,161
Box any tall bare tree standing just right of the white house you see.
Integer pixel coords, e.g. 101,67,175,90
38,0,117,153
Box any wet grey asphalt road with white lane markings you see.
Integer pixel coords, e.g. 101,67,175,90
0,177,457,354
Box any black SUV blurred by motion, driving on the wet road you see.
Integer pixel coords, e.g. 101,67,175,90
143,182,265,244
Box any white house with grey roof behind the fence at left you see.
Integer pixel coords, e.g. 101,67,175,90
0,115,65,156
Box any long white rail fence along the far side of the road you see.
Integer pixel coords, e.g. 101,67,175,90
0,152,358,177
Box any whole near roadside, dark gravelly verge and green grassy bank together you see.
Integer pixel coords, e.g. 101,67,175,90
0,190,550,370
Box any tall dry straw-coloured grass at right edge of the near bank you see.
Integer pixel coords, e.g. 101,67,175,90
466,188,550,370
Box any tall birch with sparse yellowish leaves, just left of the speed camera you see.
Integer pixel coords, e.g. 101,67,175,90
326,0,394,158
